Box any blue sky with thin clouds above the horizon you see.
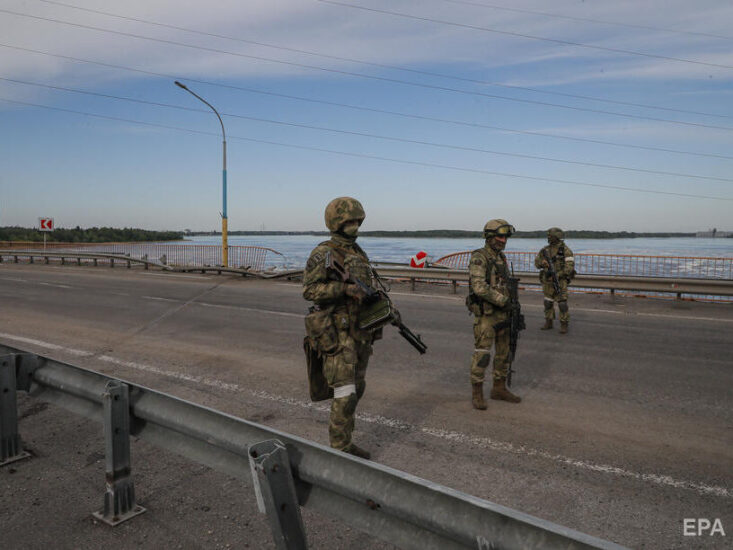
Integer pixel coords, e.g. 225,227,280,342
0,0,733,231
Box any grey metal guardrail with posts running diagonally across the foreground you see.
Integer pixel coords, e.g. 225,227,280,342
0,344,622,550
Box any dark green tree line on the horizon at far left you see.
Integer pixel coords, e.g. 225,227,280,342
0,225,183,243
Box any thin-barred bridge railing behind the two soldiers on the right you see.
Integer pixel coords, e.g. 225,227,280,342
434,251,733,280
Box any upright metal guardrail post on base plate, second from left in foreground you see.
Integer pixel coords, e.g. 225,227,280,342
92,380,145,527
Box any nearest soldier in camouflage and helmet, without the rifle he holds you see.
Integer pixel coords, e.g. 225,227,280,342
303,197,381,458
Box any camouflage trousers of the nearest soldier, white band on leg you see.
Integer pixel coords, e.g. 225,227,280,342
323,331,372,450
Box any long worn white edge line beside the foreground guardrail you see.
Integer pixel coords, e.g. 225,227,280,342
0,333,733,498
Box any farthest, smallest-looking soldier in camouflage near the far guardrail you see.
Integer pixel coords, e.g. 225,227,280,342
534,227,575,334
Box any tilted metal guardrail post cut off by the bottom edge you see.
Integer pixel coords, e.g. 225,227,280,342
249,439,308,550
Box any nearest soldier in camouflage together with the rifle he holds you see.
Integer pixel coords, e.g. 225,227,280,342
303,197,426,459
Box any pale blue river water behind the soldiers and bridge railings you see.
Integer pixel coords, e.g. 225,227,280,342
182,235,733,267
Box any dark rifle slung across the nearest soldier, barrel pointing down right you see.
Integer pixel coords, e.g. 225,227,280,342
326,251,428,354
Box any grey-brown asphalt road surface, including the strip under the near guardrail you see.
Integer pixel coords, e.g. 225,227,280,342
0,264,733,549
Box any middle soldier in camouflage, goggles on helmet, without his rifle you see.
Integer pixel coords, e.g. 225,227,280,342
466,219,521,410
